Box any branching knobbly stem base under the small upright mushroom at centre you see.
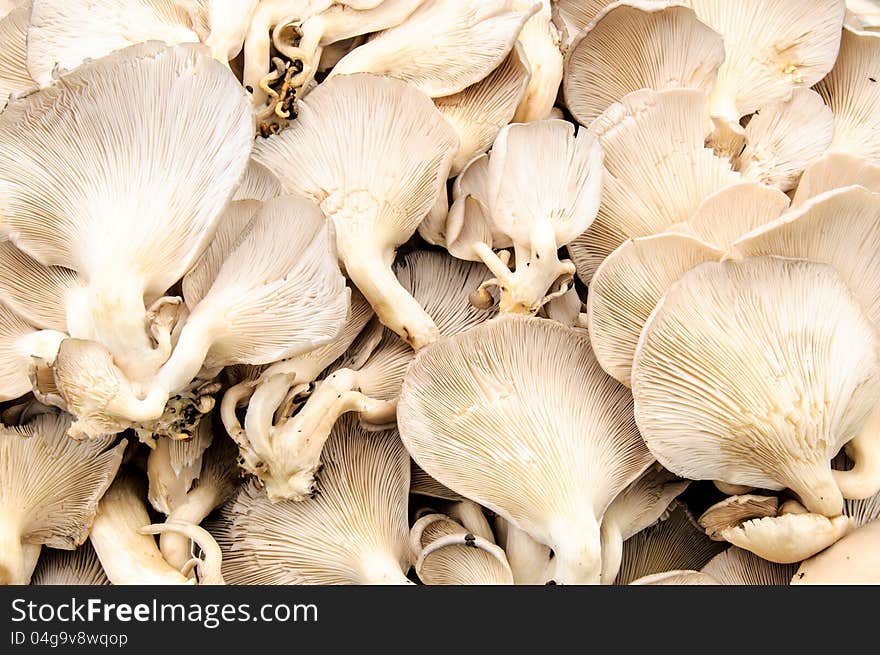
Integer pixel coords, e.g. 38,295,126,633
473,220,575,314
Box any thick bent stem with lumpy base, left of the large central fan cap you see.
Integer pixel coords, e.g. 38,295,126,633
258,368,397,501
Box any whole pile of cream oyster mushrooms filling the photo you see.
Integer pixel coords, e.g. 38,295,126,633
0,0,880,585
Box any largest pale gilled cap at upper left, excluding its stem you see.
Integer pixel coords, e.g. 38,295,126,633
0,42,253,298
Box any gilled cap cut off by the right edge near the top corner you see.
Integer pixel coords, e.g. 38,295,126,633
816,27,880,164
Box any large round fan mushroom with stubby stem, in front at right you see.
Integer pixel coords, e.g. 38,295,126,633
632,257,880,517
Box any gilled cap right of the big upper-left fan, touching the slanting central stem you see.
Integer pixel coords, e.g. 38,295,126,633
184,196,349,368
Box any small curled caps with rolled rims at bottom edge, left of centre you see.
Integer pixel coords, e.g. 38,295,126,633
410,514,513,585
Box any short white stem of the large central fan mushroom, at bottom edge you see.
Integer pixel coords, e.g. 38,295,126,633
550,515,602,585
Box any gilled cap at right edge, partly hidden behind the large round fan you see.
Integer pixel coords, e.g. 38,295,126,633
734,187,880,326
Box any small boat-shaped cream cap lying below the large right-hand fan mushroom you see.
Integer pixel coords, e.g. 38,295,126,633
721,512,852,564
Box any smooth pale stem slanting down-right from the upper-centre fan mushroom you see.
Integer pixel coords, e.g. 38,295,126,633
336,230,440,350
